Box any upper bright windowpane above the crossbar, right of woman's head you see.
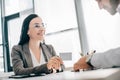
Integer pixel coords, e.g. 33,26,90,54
35,0,77,33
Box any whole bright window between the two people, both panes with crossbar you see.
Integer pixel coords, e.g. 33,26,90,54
35,0,81,67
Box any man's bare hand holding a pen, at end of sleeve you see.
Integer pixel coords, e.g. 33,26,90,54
73,56,91,71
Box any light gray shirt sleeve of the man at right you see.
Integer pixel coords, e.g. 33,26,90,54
91,47,120,68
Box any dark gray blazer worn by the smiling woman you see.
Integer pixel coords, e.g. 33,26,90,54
11,43,56,75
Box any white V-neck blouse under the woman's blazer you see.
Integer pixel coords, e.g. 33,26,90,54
30,49,46,67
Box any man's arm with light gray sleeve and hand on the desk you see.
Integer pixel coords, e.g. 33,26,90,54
74,47,120,71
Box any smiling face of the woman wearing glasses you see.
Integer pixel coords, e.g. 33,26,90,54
27,17,45,40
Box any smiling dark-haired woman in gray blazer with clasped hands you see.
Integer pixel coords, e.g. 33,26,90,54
11,14,63,75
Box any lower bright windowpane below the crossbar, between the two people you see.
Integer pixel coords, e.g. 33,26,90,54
45,29,81,67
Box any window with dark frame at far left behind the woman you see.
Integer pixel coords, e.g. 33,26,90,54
2,0,34,72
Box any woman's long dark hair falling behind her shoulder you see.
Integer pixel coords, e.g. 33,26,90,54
18,14,39,45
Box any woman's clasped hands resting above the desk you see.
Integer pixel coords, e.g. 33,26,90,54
47,56,63,70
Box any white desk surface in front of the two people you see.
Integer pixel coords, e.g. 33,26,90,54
0,68,120,80
